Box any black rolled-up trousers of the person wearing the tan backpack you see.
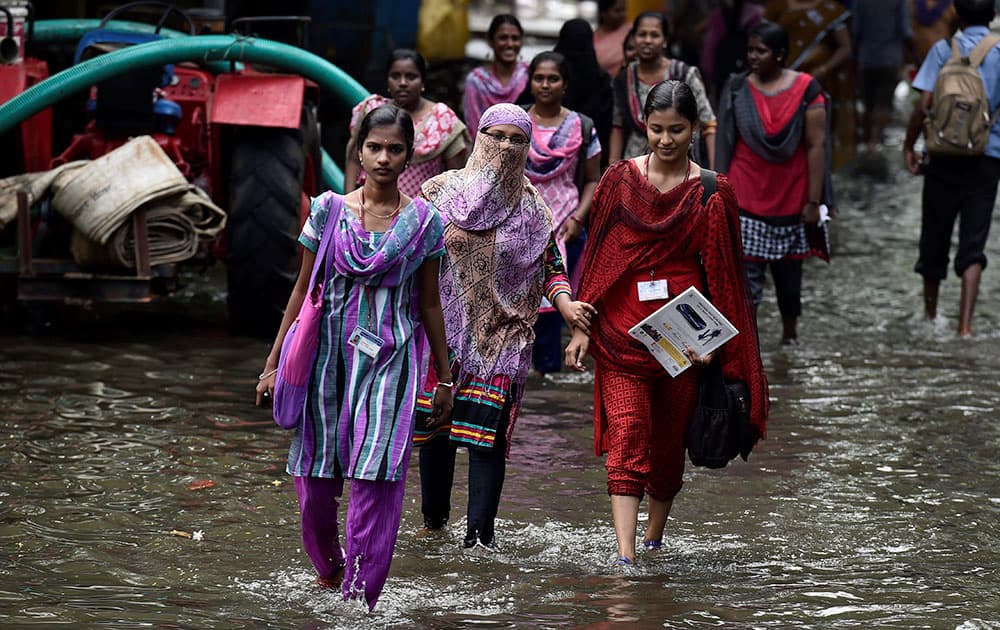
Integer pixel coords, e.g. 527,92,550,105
914,156,1000,280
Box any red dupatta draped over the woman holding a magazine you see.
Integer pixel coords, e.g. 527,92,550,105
578,160,769,454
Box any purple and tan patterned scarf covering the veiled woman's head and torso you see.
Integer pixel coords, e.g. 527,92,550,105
421,103,552,382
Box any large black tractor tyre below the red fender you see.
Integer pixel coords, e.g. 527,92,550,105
226,125,305,338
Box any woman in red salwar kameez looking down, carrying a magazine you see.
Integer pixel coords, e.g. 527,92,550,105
566,81,768,566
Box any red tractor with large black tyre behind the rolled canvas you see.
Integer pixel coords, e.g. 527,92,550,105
0,0,321,336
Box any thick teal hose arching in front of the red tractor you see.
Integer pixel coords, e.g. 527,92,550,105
0,34,368,192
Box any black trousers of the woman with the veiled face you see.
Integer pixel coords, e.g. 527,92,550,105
420,397,511,545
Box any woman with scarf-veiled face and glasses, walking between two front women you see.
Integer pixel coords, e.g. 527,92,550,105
414,104,594,547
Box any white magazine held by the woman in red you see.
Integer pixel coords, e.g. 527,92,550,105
628,287,739,376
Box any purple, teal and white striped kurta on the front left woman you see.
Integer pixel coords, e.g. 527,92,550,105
288,197,444,481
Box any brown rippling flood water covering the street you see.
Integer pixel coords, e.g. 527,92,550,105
0,154,1000,630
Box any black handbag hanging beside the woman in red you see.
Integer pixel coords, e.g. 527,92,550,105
684,358,758,468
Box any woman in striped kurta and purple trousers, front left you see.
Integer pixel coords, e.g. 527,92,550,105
257,105,452,608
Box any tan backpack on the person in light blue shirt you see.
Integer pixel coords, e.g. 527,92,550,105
924,35,1000,156
